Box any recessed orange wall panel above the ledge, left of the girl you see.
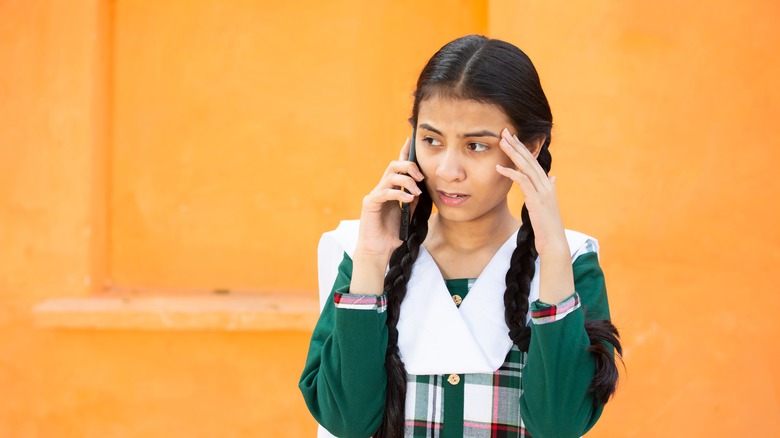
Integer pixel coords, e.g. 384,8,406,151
110,0,487,290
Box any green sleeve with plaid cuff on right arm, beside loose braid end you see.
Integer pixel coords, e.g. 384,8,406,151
520,252,609,437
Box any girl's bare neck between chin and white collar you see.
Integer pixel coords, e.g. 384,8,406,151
426,202,520,252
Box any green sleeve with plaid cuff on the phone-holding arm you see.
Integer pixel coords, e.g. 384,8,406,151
298,254,387,437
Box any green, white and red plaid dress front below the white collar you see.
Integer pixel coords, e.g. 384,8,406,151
405,347,531,438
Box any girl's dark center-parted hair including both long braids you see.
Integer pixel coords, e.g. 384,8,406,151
376,35,622,438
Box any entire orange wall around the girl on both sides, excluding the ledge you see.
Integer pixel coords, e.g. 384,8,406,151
0,0,780,437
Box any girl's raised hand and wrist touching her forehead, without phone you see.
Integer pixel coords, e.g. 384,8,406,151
496,129,569,256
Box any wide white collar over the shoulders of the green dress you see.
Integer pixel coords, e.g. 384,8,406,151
318,220,598,374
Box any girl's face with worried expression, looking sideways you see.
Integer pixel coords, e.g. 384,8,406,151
416,97,517,221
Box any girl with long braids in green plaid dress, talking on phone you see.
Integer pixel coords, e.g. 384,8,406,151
299,36,622,437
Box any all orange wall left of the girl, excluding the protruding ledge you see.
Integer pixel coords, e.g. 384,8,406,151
0,0,487,437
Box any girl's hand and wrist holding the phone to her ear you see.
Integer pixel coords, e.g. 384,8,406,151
355,138,425,259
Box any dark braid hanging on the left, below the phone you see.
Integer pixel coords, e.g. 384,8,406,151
375,184,433,438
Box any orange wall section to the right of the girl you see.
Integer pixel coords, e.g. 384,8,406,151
491,0,780,437
